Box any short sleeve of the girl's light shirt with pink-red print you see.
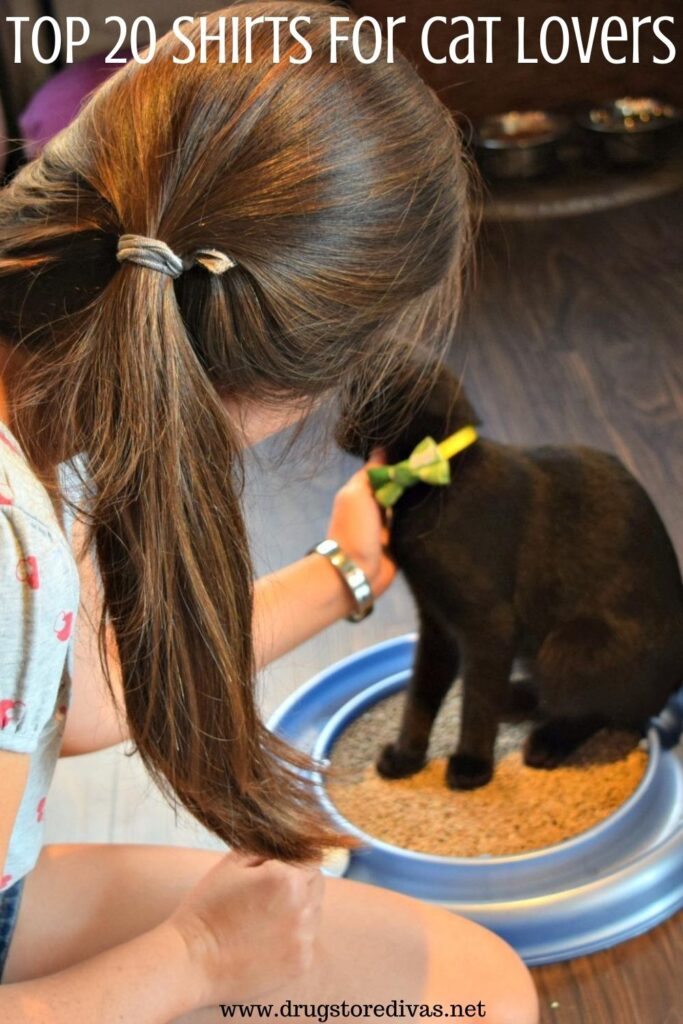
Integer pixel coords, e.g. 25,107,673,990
0,506,79,754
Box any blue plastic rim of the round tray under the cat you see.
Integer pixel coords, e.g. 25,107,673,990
268,634,683,965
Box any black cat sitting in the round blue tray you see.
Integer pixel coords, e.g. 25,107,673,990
337,356,683,788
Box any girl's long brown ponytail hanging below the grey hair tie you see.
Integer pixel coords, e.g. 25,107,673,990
13,243,352,860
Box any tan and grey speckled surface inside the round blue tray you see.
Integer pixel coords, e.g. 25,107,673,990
327,683,647,857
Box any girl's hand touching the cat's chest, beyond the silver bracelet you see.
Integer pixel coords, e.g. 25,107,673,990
327,449,396,597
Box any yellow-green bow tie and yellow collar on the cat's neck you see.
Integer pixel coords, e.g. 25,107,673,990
368,427,478,508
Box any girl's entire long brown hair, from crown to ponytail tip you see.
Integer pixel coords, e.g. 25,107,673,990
0,2,470,860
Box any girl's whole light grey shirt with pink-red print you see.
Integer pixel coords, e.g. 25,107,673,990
0,423,79,890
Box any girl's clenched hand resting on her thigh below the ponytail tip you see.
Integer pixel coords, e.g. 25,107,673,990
167,852,325,1006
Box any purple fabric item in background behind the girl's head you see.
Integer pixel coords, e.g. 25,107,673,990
19,52,130,160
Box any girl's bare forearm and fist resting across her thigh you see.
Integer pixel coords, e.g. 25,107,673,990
0,853,325,1024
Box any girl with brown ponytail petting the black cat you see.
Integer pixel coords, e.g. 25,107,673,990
0,8,537,1024
